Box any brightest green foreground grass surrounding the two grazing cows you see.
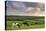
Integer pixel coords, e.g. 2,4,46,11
6,21,45,30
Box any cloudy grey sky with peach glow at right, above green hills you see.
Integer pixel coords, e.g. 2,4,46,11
6,1,45,16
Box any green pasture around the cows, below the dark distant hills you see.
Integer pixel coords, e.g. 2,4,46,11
6,17,45,30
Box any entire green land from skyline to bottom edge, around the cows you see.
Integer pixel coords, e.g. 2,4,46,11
6,16,45,30
